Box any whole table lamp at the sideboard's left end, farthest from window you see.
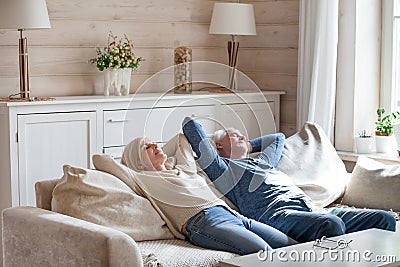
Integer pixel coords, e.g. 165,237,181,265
0,0,50,99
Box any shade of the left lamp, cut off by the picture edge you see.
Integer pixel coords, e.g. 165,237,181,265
0,0,50,30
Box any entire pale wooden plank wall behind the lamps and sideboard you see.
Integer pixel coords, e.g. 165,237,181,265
0,0,299,133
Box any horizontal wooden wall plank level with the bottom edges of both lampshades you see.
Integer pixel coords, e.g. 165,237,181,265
0,20,298,48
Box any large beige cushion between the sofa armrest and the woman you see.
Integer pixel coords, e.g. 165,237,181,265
51,165,173,241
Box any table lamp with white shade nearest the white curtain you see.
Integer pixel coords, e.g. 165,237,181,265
209,3,256,90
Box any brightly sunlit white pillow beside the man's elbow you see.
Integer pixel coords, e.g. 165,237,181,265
278,122,349,207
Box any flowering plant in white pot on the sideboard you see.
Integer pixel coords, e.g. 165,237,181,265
89,32,144,96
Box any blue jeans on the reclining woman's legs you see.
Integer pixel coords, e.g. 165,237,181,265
185,206,297,255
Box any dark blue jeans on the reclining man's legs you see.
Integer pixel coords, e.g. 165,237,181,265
260,208,396,242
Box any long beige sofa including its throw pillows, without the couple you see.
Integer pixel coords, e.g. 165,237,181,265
2,123,400,266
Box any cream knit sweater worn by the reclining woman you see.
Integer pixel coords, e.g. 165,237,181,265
122,134,228,239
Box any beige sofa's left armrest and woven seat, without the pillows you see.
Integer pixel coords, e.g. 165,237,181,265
3,180,237,266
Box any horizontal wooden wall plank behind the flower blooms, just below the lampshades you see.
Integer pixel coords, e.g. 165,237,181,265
0,47,297,77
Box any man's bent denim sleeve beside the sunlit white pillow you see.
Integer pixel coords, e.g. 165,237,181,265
249,133,285,168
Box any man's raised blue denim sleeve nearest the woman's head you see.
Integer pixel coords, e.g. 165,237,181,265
182,117,227,181
